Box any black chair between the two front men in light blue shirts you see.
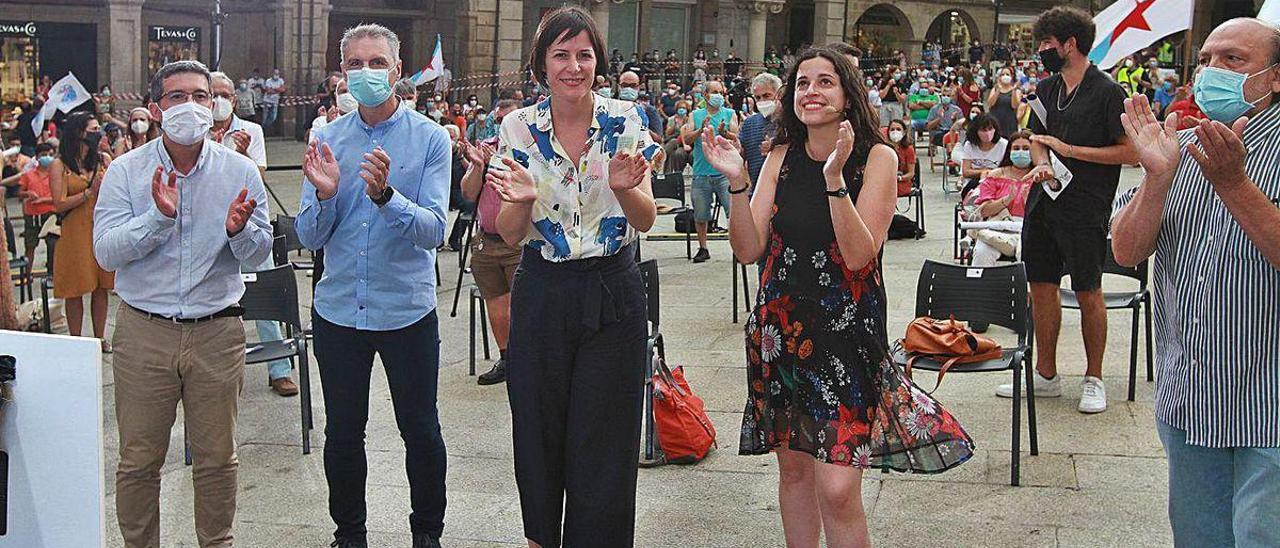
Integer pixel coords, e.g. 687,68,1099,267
241,265,315,455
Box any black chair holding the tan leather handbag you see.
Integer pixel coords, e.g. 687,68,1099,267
893,260,1039,485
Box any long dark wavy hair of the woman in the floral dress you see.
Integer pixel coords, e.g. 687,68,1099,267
776,47,888,159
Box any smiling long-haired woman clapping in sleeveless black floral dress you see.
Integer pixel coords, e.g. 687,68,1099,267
703,49,973,547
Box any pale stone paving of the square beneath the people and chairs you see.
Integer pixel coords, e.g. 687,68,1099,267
60,142,1171,548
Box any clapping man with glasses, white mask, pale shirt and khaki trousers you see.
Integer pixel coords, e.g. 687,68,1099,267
93,61,271,547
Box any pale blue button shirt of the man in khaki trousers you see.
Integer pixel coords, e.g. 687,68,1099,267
93,138,271,318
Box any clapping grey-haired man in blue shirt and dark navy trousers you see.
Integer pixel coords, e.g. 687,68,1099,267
297,24,452,548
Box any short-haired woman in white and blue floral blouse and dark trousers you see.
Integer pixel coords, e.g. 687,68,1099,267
488,8,659,547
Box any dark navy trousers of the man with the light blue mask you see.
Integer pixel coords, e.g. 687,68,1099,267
311,310,445,539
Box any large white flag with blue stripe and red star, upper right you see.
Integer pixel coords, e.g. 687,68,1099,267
1089,0,1192,70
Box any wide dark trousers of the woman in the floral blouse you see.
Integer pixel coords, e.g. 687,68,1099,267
507,246,648,548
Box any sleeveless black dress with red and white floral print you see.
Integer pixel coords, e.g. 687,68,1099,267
739,145,973,472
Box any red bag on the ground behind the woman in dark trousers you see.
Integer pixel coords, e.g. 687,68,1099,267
653,360,717,465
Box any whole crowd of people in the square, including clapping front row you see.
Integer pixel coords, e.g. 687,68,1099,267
4,6,1280,548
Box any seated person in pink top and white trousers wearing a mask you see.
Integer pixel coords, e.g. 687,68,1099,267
968,132,1034,266
